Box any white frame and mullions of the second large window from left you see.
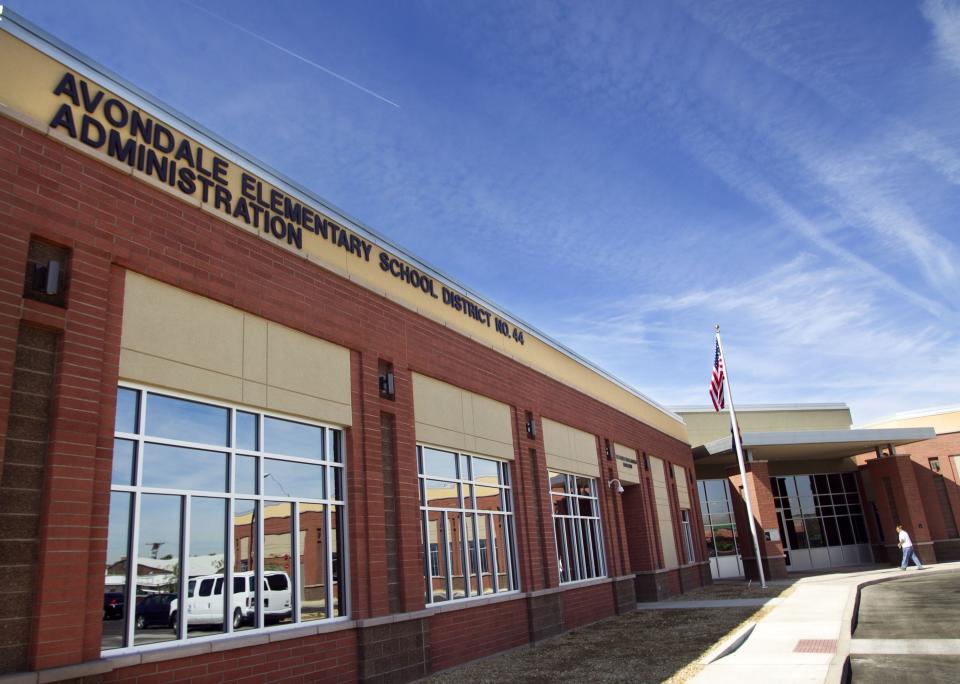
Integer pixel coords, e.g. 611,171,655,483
416,441,520,608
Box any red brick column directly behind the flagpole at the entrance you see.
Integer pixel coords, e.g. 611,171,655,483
727,461,787,579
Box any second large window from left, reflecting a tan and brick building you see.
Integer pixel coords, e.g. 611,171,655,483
417,446,519,604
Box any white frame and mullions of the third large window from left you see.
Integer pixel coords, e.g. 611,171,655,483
547,470,609,586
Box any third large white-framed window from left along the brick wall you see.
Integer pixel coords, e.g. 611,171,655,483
549,472,607,582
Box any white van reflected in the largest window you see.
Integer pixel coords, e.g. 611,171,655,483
170,570,291,629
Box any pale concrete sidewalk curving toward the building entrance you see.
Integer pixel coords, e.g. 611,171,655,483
691,563,960,684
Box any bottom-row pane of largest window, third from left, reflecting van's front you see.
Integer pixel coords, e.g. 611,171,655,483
187,496,226,637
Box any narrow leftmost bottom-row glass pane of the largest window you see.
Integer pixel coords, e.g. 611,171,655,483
100,492,133,650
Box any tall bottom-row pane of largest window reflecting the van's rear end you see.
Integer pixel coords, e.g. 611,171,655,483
263,501,293,626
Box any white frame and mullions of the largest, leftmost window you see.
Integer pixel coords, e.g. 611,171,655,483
100,380,351,657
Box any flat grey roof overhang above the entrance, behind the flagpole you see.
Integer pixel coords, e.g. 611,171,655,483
693,427,936,465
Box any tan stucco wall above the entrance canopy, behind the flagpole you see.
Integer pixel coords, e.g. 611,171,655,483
678,408,852,447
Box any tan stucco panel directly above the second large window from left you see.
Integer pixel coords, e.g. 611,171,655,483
413,373,514,460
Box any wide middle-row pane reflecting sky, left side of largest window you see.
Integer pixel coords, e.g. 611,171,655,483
142,444,227,492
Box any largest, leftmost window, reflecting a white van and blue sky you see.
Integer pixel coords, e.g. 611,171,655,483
101,386,347,650
